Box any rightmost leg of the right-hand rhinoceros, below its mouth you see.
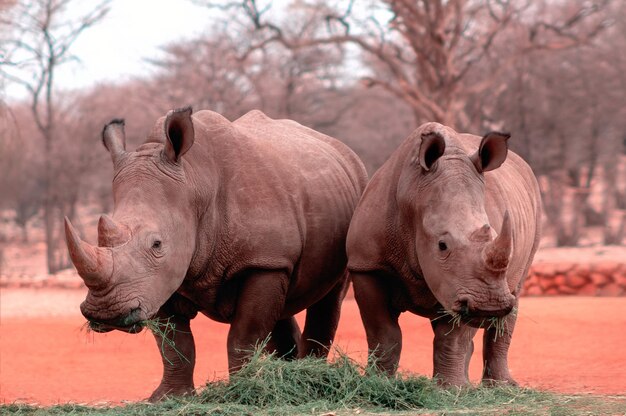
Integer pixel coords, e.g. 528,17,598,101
483,304,517,386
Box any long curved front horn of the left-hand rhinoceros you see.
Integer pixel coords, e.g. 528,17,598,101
65,217,113,288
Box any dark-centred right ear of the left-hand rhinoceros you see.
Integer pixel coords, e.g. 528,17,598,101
163,107,194,162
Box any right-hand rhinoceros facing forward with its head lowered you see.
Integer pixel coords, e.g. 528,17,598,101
347,123,541,386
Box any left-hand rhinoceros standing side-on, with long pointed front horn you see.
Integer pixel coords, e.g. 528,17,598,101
65,108,367,400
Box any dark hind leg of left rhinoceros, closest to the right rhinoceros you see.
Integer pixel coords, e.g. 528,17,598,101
299,274,349,357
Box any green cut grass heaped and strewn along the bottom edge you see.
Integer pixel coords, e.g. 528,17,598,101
0,349,626,416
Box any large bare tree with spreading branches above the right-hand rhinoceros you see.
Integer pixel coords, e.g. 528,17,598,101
195,0,610,127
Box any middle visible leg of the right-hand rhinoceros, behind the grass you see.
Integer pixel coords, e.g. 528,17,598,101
431,319,477,386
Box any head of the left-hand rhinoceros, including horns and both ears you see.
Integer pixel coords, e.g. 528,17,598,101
65,108,196,332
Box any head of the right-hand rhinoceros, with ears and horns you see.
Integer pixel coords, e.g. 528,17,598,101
405,123,515,321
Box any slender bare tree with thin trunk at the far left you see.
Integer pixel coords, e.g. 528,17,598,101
0,0,110,273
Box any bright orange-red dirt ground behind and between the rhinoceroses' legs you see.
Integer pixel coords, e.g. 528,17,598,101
0,289,626,405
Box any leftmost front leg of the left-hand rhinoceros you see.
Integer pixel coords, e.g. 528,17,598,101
148,301,196,402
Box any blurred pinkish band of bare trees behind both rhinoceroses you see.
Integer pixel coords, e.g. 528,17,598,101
0,0,626,273
